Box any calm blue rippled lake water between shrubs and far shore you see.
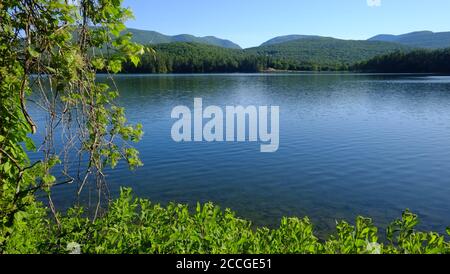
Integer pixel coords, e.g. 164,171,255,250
29,74,450,237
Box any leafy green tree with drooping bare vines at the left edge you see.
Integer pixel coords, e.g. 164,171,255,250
0,0,143,248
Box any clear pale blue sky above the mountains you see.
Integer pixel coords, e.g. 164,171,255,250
124,0,450,48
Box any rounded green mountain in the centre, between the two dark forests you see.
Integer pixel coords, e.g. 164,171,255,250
245,37,412,67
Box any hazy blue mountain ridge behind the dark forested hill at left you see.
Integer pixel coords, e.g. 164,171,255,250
125,28,241,49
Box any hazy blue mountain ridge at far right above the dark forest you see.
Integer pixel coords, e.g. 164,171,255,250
368,31,450,49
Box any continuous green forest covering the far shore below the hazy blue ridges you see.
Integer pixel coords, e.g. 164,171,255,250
122,39,450,73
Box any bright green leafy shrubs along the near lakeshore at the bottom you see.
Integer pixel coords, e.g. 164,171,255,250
0,188,450,254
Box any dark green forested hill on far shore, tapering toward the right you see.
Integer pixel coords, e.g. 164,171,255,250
124,42,316,73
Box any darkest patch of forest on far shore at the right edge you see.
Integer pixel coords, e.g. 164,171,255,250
352,48,450,73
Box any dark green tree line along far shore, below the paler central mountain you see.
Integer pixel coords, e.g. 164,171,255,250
123,42,450,73
